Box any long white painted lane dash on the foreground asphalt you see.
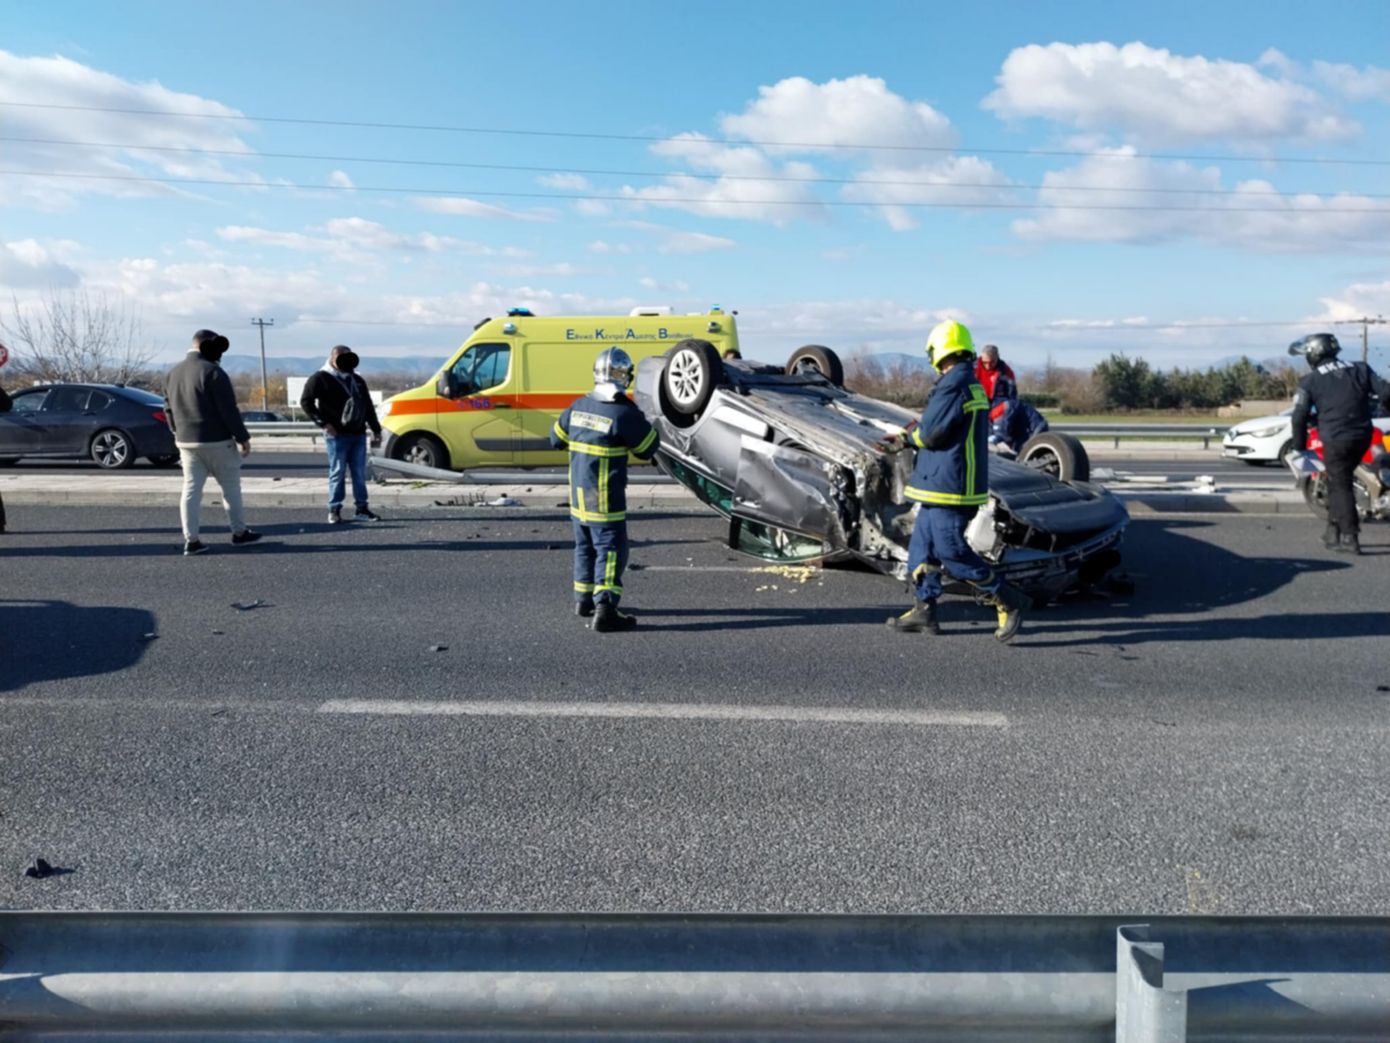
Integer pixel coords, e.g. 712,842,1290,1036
318,700,1009,727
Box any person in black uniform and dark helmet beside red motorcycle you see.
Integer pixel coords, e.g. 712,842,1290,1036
1289,334,1390,553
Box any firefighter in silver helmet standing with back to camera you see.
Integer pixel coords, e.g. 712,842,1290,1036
550,348,657,633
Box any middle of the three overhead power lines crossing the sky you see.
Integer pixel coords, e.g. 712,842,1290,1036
0,136,1390,199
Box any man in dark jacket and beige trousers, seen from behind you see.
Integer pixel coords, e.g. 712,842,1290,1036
164,330,260,555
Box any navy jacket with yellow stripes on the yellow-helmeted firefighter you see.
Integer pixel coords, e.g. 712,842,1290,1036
904,363,990,508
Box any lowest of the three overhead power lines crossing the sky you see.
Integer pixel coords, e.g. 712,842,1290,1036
0,170,1390,217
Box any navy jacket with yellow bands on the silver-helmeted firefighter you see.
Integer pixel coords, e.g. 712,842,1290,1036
550,395,657,524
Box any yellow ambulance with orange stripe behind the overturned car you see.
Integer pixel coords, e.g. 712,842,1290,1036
369,307,738,470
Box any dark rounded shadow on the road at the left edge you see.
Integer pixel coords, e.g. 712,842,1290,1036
0,601,154,691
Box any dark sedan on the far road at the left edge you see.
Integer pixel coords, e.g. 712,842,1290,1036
0,384,178,470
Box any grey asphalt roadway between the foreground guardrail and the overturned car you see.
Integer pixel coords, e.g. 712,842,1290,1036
0,509,1390,915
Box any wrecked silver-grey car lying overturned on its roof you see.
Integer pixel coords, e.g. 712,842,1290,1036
634,341,1129,598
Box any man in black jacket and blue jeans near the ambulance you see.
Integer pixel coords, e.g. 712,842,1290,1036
299,343,381,526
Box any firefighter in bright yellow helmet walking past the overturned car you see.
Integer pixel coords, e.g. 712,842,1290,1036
888,321,1033,641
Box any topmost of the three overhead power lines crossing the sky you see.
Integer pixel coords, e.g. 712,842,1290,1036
0,102,1390,167
